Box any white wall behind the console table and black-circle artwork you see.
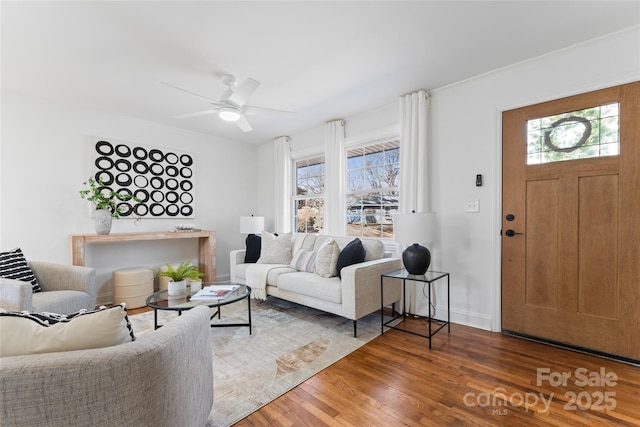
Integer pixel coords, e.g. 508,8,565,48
0,92,259,303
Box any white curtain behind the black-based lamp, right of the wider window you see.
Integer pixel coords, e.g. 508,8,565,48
399,90,430,316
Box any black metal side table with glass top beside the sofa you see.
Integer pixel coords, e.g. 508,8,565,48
380,269,451,349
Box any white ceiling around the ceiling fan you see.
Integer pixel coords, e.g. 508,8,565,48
0,1,640,143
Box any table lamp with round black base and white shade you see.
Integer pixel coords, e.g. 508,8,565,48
393,211,436,275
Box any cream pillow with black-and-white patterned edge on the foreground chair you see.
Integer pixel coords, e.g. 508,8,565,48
0,304,135,357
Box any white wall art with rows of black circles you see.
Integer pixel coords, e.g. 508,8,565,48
91,138,195,218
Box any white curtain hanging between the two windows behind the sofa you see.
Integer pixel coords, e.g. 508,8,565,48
324,120,346,236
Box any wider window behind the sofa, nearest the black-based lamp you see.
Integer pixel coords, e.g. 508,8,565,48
346,140,400,238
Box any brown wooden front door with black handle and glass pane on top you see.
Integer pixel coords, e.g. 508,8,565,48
502,82,640,360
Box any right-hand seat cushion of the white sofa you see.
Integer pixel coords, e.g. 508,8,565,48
278,271,342,304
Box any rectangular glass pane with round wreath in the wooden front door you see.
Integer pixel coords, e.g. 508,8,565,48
527,103,620,165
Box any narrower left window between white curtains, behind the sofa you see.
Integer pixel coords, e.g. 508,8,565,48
293,156,324,233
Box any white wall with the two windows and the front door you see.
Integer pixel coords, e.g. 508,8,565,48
260,28,640,330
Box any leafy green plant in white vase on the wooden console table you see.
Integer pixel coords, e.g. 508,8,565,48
79,177,139,234
